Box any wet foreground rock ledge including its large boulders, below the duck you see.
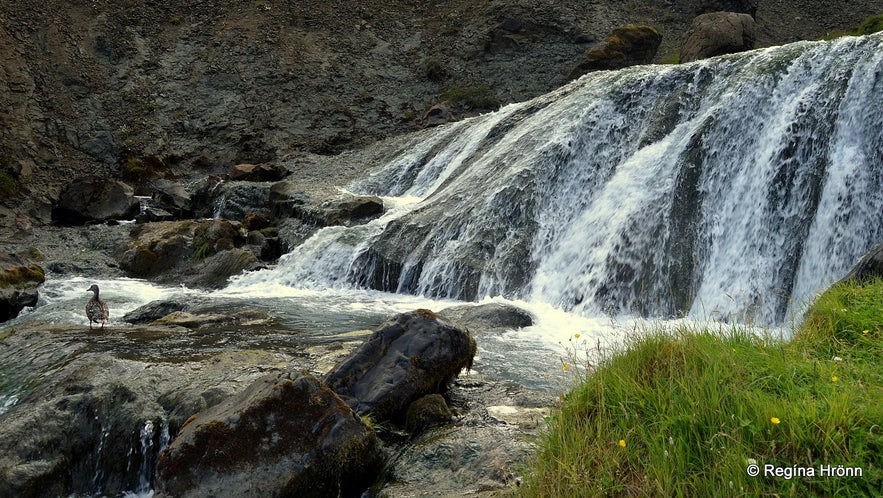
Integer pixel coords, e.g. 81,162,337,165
0,302,548,497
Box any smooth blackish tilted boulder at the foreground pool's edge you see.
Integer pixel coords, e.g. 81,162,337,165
324,310,476,422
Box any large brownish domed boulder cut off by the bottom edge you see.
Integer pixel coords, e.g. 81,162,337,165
156,372,383,497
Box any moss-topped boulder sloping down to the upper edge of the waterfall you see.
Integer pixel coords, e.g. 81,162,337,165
569,24,662,80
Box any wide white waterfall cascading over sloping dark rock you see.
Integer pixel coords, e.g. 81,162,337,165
232,35,883,324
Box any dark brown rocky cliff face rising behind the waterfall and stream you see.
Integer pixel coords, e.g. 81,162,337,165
0,0,883,228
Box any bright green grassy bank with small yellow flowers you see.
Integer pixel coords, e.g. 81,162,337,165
520,280,883,496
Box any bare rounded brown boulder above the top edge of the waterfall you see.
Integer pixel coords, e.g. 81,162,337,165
680,12,757,62
